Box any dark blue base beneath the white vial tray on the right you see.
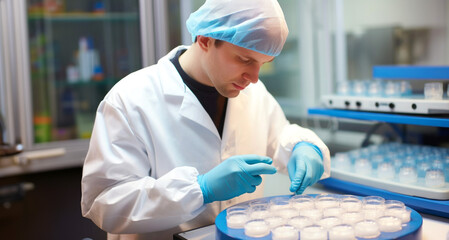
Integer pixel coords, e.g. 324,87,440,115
319,178,449,218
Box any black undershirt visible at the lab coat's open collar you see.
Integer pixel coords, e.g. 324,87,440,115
170,49,228,137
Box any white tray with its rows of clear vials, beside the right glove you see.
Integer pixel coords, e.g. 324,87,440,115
332,143,449,200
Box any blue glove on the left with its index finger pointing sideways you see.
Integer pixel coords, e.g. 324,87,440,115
198,155,276,203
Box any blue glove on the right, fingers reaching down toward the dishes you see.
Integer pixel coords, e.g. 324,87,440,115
287,142,324,194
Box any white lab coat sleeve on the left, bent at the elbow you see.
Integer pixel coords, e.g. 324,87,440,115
81,101,204,234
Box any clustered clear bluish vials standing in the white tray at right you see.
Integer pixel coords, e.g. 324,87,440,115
332,143,449,188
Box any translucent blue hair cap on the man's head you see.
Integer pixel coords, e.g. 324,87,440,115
186,0,288,56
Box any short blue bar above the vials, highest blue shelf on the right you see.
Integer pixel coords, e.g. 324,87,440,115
373,66,449,80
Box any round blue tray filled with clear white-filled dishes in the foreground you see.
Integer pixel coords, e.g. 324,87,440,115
215,194,422,240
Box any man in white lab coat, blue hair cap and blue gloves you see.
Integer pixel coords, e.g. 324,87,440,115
81,0,330,239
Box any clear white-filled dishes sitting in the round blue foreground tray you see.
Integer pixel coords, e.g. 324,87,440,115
226,194,411,240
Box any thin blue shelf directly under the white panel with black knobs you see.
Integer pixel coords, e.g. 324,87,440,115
308,108,449,127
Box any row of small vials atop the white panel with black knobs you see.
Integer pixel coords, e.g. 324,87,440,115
337,80,449,100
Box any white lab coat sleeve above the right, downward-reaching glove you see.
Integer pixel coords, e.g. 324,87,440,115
265,87,331,179
